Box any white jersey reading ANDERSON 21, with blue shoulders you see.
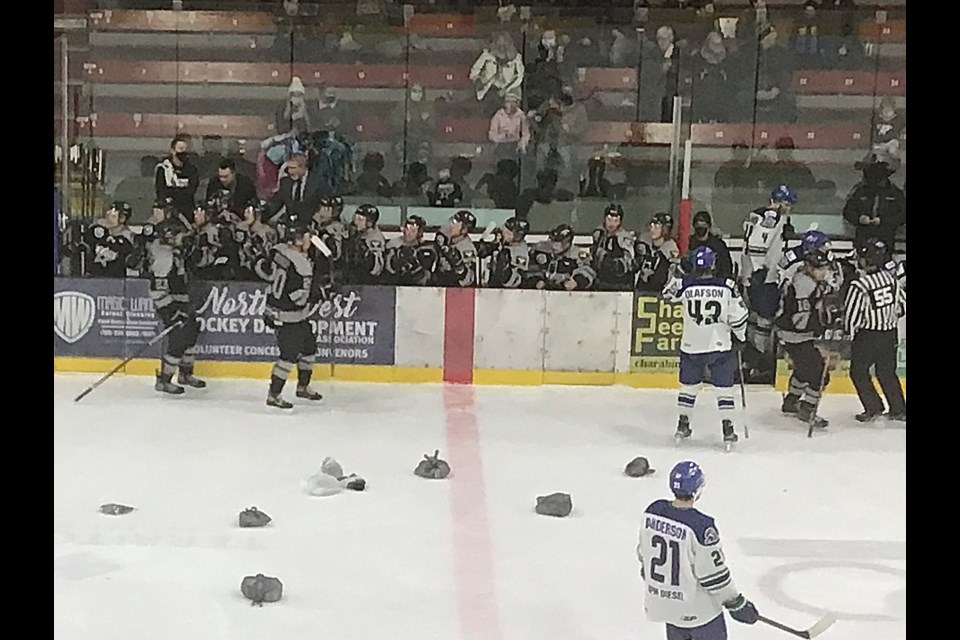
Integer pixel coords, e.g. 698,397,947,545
637,500,740,627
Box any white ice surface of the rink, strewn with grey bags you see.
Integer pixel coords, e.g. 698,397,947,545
53,374,906,640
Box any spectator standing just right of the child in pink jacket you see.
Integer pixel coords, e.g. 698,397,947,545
533,93,588,188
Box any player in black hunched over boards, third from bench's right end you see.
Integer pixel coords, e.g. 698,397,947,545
530,224,597,291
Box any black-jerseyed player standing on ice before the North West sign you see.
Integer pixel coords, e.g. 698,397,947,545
259,220,325,409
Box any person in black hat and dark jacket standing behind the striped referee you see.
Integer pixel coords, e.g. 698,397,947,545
843,158,907,247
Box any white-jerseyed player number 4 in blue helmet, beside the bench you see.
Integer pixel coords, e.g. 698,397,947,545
740,185,797,382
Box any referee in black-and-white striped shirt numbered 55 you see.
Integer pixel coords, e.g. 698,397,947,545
844,238,907,422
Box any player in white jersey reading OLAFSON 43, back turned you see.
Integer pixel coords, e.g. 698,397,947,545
663,247,747,447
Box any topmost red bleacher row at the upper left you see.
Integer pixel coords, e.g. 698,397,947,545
89,10,276,33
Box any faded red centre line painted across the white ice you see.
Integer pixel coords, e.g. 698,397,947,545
443,386,501,640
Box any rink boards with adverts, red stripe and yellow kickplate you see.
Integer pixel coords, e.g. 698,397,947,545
54,278,906,393
